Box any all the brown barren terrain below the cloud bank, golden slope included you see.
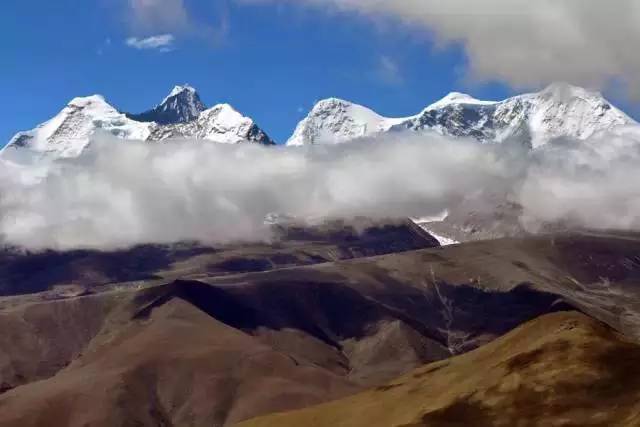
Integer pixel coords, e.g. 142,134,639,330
0,225,640,427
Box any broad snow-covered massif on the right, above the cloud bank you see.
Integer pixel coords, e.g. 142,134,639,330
288,84,637,148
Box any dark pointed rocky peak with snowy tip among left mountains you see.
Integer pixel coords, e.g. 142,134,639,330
129,85,207,125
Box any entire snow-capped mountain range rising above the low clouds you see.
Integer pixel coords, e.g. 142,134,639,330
2,83,638,163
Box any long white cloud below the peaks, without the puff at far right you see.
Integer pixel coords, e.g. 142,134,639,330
0,136,511,249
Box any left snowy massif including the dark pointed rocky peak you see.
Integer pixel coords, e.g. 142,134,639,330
0,86,273,163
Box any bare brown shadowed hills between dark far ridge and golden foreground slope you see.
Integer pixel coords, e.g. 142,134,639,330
0,234,640,426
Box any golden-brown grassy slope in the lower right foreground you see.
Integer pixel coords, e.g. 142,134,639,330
238,312,640,427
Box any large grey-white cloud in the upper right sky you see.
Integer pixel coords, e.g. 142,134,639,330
236,0,640,95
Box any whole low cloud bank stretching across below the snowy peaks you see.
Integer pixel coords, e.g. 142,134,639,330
0,128,640,249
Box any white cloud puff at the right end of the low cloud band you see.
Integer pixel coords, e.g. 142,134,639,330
519,127,640,231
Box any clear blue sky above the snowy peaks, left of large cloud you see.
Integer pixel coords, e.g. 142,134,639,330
0,0,638,144
